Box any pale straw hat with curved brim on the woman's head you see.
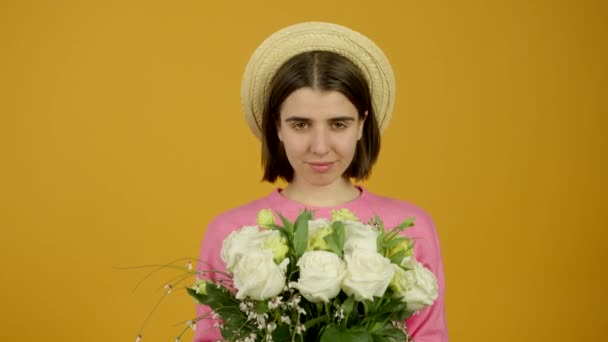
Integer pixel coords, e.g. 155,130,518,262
241,22,395,139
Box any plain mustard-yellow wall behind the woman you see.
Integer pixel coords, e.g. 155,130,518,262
0,0,608,341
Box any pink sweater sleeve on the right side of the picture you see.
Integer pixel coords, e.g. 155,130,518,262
406,211,448,342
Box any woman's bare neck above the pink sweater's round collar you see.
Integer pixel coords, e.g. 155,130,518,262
281,179,361,207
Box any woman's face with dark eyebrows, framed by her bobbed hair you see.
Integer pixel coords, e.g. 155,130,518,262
277,87,364,186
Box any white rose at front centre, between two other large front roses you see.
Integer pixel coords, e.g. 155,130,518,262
289,251,346,303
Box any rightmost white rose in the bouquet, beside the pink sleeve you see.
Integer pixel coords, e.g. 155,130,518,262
391,262,439,311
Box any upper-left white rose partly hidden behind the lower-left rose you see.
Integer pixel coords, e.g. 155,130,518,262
220,226,272,272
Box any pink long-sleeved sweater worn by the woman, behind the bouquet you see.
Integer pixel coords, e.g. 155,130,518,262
194,187,448,342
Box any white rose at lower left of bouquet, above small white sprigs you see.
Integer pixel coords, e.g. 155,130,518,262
234,250,289,300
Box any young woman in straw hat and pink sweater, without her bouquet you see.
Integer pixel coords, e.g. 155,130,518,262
194,23,448,342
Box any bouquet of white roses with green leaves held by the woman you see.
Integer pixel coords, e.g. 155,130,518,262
187,209,438,342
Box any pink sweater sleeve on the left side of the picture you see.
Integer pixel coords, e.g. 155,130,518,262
193,219,225,342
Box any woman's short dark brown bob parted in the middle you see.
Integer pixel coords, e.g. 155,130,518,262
262,51,380,183
